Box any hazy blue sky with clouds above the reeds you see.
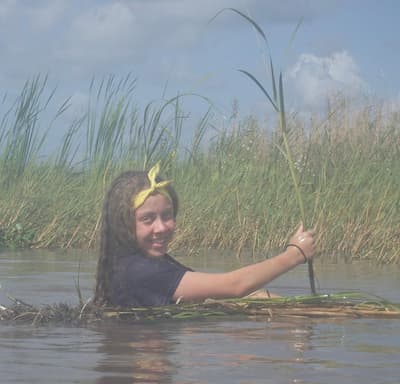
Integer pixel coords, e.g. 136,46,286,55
0,0,400,142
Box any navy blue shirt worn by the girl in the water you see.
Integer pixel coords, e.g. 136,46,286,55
111,253,190,307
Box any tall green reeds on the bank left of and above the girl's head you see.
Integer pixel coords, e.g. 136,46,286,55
0,76,195,247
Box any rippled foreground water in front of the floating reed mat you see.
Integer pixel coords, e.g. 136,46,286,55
0,319,400,384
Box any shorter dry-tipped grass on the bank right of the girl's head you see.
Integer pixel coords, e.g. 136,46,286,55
171,99,400,263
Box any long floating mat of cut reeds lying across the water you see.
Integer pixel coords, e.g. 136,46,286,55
0,292,400,326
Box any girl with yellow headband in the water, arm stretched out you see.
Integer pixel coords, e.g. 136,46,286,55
94,164,315,307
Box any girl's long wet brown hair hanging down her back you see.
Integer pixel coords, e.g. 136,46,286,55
94,171,178,305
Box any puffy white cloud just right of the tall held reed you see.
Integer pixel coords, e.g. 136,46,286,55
286,51,368,109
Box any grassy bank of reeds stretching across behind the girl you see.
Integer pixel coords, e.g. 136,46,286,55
0,78,400,264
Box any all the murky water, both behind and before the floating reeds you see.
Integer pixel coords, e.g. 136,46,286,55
0,251,400,384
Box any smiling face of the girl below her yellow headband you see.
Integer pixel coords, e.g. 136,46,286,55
135,193,175,257
